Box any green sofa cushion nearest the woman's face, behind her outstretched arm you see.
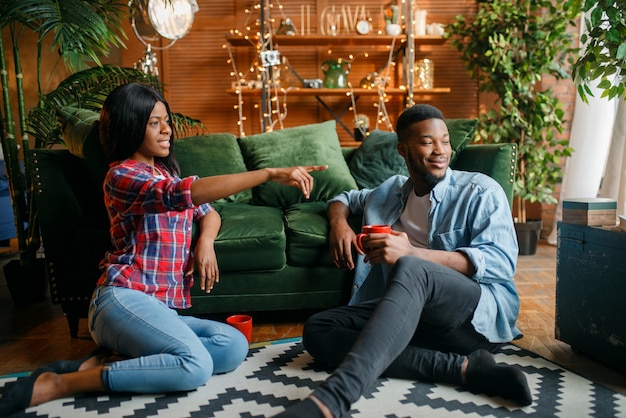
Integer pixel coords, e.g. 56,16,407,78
174,133,252,203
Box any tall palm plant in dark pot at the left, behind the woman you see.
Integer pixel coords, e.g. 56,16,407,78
0,0,201,301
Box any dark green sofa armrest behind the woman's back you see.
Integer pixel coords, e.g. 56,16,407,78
31,149,111,303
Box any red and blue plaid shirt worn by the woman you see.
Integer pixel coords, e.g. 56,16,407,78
98,160,213,308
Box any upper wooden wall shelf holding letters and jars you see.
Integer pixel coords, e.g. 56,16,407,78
226,35,446,46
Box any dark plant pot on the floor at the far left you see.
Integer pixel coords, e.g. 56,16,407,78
4,258,48,305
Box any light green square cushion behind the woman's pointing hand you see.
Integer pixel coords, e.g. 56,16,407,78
239,120,357,208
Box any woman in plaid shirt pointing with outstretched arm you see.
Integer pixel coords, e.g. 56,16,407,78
0,84,327,416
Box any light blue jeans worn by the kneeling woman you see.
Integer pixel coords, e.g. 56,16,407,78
89,286,248,393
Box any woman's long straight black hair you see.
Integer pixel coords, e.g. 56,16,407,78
99,83,180,175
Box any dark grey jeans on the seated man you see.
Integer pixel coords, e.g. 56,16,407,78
303,257,499,417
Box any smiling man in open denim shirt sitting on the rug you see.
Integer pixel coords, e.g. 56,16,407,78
278,105,532,418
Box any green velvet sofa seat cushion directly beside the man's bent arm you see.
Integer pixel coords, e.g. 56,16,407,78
285,202,361,266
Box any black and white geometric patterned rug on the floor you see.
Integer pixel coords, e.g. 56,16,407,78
0,339,626,418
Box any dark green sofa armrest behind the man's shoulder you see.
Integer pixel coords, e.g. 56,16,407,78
452,143,517,206
